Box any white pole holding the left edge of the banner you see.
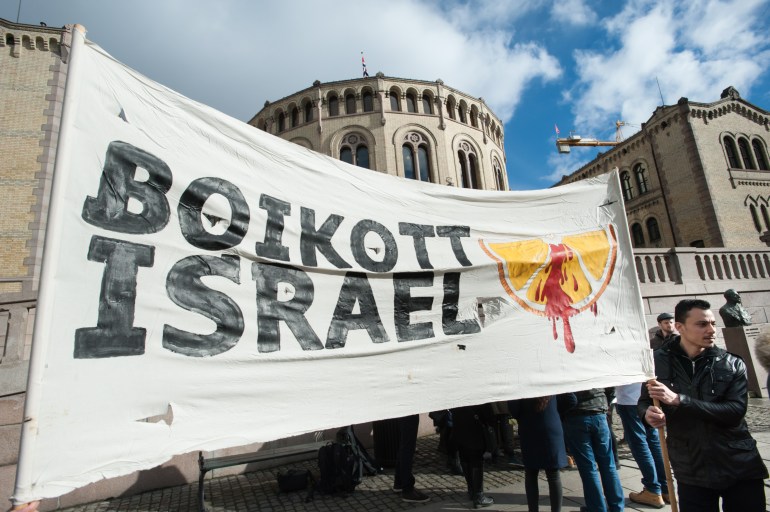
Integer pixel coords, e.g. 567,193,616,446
11,25,86,506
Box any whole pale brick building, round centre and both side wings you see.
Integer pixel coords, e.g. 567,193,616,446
0,19,770,510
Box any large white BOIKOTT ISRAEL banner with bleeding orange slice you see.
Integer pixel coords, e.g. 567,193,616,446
14,31,652,502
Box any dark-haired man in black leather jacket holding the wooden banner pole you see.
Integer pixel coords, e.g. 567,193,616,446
639,299,767,512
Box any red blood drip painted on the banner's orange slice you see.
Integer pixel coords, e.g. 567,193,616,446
535,244,578,353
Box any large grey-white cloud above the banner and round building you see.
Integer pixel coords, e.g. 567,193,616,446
4,0,562,122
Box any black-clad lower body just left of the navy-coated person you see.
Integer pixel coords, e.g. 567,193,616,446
452,404,495,508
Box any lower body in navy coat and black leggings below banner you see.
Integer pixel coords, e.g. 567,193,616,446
508,396,567,512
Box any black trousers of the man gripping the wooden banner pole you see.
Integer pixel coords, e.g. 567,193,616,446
677,480,766,512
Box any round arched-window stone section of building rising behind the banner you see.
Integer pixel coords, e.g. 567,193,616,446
249,73,508,190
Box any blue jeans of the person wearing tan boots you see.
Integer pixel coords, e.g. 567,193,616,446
616,405,668,494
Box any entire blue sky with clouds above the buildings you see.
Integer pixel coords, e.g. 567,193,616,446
0,0,770,190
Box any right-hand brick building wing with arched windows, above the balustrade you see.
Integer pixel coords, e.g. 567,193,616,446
557,87,770,252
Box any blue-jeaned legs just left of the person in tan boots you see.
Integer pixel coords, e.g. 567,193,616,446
563,415,607,512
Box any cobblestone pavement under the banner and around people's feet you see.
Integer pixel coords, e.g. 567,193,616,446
62,399,770,512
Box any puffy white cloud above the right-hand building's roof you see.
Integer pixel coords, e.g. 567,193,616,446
570,0,770,137
